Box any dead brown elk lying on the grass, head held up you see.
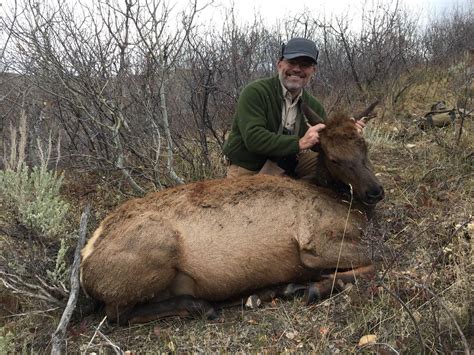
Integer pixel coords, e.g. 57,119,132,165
81,108,384,324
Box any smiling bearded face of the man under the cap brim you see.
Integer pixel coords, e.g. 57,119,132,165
277,57,316,93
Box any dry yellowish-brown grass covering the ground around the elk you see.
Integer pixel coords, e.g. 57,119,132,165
0,69,474,354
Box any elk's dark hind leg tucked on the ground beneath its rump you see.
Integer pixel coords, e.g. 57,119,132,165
118,295,217,325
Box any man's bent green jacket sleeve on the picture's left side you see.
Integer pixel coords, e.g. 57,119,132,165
237,86,299,157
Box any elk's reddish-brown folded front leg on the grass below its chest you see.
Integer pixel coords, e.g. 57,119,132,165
304,265,375,304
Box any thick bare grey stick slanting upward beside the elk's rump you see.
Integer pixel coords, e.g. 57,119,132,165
51,204,91,354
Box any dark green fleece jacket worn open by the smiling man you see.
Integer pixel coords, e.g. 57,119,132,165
223,76,326,171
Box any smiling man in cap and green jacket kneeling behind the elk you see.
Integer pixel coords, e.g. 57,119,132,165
224,38,363,178
